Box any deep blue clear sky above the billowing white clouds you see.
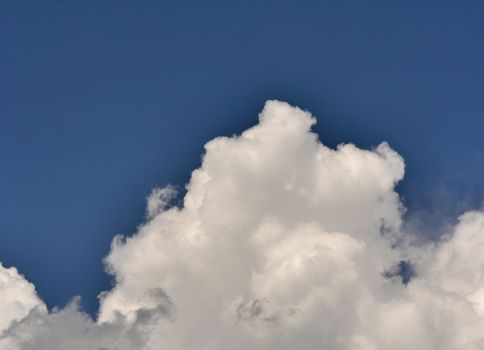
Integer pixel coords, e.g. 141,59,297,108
0,0,484,318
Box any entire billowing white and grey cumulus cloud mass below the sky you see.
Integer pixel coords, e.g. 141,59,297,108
0,101,484,350
